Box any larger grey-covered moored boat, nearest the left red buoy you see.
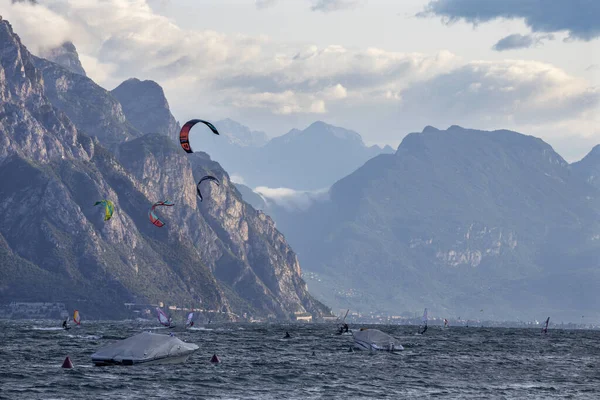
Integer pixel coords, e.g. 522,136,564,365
92,332,198,366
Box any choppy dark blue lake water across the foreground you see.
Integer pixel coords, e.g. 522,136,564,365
0,321,600,400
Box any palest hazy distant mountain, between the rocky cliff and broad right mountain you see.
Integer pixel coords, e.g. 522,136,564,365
191,120,393,190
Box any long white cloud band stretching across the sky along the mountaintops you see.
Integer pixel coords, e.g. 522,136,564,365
5,0,600,159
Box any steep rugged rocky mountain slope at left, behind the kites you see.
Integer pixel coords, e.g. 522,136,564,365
0,20,327,319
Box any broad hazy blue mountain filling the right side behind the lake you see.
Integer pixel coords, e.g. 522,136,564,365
277,126,600,320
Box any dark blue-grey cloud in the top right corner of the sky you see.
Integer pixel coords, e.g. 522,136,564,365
417,0,600,41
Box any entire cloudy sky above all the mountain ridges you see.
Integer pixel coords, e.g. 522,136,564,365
0,0,600,162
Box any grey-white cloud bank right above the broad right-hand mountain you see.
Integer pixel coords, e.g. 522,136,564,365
401,60,600,135
